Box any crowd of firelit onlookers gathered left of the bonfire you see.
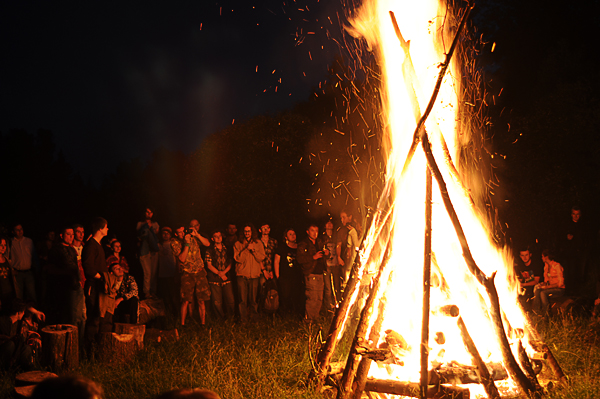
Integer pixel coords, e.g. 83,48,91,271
0,208,361,366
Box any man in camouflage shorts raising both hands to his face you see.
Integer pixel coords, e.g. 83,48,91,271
171,220,210,326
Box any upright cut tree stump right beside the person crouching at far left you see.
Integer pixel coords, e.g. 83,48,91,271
40,324,79,371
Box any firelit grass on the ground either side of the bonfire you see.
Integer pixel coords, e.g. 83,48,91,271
0,317,600,399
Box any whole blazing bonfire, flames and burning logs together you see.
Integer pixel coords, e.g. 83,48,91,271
310,0,564,398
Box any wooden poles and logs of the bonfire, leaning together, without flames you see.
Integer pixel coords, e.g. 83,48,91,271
309,5,566,399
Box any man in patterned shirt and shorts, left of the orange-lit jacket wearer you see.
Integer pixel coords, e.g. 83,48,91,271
206,231,235,318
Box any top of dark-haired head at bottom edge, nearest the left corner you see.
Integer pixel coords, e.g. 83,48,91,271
31,376,102,399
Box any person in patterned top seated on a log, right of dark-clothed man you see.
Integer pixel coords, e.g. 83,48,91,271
109,263,140,324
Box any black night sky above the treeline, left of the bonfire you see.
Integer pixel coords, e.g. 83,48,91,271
0,0,340,179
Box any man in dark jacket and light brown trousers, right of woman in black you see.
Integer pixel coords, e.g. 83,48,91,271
296,224,329,323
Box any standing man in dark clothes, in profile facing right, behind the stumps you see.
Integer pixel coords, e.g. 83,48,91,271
81,217,108,349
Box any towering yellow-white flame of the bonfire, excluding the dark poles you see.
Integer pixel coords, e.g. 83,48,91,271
348,0,526,396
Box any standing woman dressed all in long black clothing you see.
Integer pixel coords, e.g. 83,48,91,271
273,229,304,316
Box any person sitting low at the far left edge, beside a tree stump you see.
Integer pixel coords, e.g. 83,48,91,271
0,299,46,370
